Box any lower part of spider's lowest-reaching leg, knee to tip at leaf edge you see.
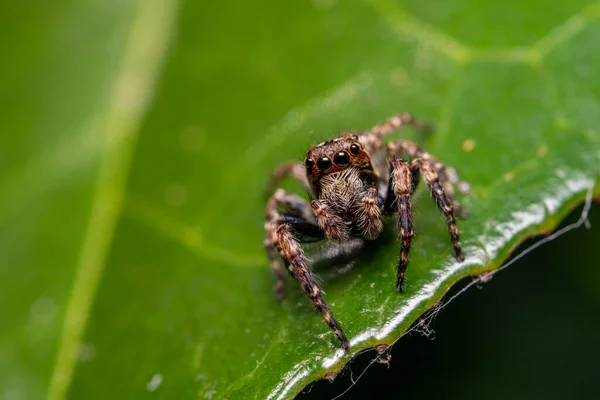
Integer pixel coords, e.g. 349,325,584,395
276,222,350,350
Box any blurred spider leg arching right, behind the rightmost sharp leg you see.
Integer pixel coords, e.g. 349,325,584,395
388,140,468,218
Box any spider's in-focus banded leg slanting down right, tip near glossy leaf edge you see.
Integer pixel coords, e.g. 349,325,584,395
411,158,465,261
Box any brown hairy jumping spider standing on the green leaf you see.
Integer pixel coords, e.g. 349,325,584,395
265,113,465,349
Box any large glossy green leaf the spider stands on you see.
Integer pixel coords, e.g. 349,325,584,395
0,0,600,399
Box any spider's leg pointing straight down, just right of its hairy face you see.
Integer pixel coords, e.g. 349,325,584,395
389,159,414,292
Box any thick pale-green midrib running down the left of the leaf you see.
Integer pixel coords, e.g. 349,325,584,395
47,0,177,400
